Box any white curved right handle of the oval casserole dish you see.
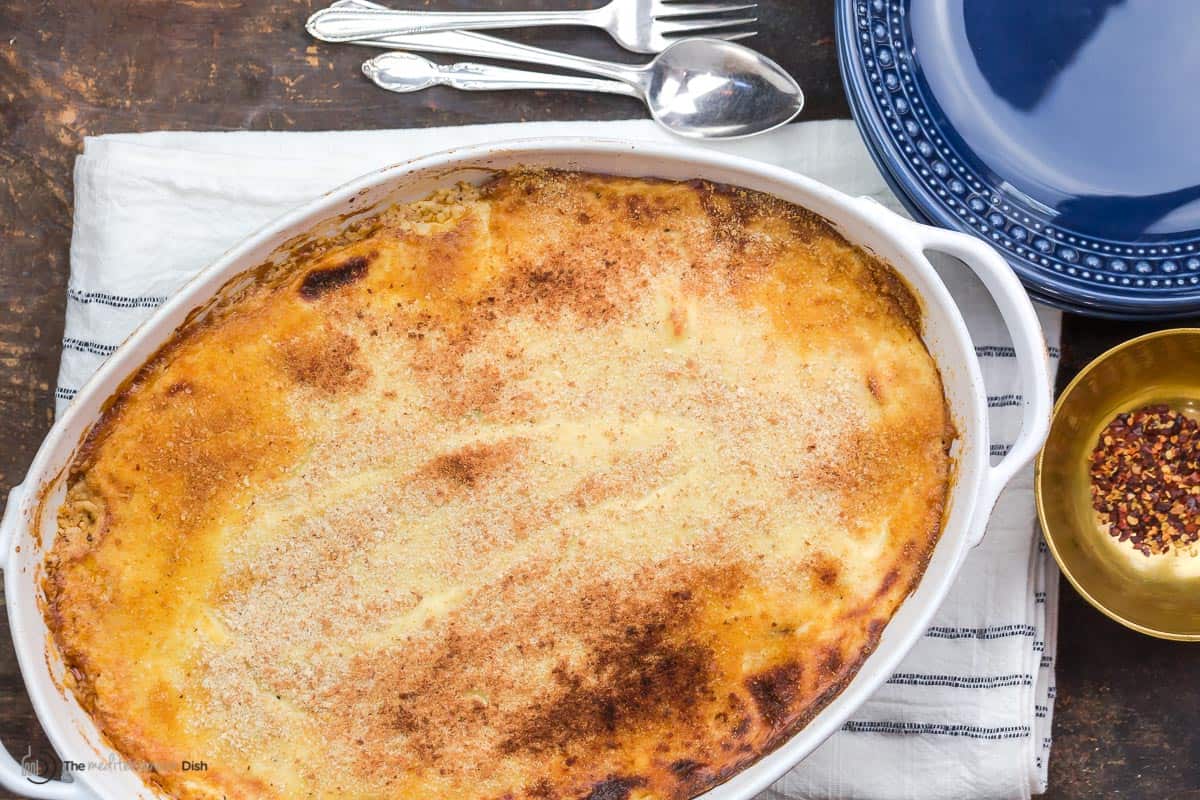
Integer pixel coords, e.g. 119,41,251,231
910,222,1054,547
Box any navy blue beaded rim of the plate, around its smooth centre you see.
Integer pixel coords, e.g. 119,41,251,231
836,0,1200,319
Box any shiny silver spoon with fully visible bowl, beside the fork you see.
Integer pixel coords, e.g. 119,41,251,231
321,0,804,139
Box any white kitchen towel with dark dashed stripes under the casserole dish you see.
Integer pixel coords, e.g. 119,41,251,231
63,120,1061,800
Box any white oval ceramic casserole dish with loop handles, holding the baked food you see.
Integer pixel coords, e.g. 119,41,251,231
0,139,1051,800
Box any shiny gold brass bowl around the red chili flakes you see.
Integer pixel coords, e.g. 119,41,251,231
1034,327,1200,642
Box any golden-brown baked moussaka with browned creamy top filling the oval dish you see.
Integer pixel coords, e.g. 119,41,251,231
44,170,954,800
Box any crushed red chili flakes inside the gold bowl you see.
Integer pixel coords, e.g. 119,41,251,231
1090,405,1200,557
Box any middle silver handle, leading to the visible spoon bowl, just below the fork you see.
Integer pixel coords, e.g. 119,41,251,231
319,0,644,89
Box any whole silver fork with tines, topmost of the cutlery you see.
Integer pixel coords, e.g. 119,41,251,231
307,0,757,53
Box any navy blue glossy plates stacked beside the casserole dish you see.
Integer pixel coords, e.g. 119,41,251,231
838,0,1200,318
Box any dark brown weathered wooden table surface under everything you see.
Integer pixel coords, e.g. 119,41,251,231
0,0,1200,799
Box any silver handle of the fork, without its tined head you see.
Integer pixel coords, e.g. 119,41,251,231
307,6,610,42
